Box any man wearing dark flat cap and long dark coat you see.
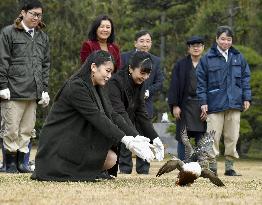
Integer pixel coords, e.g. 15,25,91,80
168,36,206,161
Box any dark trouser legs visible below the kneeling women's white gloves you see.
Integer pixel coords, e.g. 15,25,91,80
119,144,150,174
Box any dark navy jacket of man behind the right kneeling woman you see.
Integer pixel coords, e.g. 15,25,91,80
121,50,164,118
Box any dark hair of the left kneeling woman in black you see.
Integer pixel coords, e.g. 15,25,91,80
86,50,115,69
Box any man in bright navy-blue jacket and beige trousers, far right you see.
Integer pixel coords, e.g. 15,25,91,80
197,26,251,176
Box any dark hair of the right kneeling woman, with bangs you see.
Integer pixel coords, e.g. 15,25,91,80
129,51,152,73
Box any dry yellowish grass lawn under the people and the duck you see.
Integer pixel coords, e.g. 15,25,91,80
0,154,262,205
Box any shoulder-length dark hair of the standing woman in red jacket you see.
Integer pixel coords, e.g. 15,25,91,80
88,15,115,43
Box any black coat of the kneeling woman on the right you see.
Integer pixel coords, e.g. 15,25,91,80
108,69,158,140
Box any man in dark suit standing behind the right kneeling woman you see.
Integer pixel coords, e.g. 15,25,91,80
119,30,164,174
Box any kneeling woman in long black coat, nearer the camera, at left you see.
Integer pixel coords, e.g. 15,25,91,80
31,51,154,181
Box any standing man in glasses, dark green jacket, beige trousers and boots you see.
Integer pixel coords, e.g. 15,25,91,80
0,0,50,173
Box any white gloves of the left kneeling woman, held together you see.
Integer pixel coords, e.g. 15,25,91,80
121,136,155,162
